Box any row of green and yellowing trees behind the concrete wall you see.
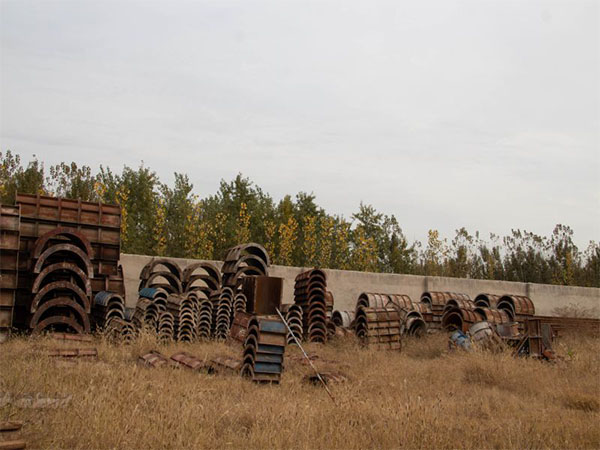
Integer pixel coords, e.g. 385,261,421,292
0,150,600,287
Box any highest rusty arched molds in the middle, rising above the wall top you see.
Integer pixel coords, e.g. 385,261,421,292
221,243,271,290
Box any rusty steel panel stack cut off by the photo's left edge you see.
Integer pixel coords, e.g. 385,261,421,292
0,205,21,342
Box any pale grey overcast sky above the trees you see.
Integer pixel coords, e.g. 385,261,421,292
0,0,600,247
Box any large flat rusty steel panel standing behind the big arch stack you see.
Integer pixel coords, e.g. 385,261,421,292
15,194,125,306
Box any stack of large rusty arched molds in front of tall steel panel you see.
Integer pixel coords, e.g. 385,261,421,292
29,228,94,334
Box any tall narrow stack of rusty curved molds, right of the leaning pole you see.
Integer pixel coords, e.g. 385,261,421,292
294,269,328,342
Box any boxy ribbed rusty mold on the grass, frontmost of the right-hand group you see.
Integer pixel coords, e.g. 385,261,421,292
354,306,402,350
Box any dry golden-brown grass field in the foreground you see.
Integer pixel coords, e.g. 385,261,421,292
0,335,600,449
